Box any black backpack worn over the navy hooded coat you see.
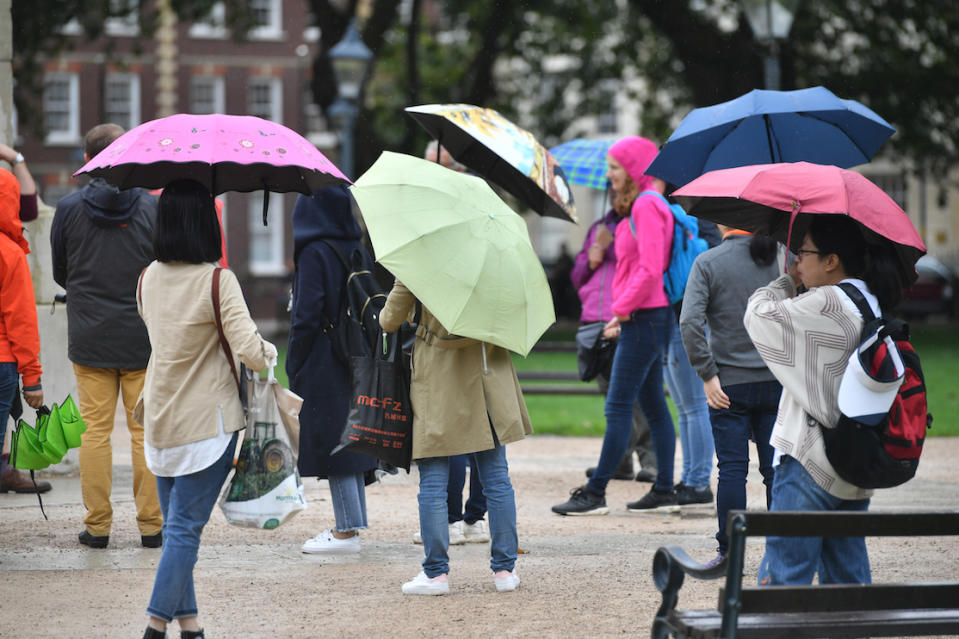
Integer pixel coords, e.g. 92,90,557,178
322,240,386,368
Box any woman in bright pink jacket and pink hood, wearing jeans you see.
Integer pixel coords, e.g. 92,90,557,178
553,137,676,515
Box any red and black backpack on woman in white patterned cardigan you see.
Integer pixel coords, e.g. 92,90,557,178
822,283,932,488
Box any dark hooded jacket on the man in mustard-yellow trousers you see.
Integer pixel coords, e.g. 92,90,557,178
50,178,157,370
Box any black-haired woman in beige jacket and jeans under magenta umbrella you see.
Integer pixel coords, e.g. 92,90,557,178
137,180,276,639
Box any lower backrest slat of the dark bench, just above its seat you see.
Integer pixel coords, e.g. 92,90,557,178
718,582,959,614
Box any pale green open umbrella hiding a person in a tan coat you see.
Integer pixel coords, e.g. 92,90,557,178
350,152,556,355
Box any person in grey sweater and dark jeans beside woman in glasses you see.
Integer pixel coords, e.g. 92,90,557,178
679,225,782,562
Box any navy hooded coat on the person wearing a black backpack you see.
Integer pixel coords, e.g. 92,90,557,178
286,186,377,478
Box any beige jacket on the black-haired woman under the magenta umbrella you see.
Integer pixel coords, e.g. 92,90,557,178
137,262,276,448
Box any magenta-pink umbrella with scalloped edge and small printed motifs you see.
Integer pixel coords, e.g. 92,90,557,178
74,113,349,195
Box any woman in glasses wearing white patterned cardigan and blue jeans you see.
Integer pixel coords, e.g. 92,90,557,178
744,215,902,585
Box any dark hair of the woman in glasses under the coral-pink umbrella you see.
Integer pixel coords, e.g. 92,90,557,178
809,215,902,313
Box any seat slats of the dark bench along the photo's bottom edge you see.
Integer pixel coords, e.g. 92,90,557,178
668,609,959,639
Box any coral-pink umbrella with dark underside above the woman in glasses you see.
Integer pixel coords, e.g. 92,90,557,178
673,162,926,287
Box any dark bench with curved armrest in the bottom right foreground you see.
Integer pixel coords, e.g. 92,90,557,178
652,511,959,639
